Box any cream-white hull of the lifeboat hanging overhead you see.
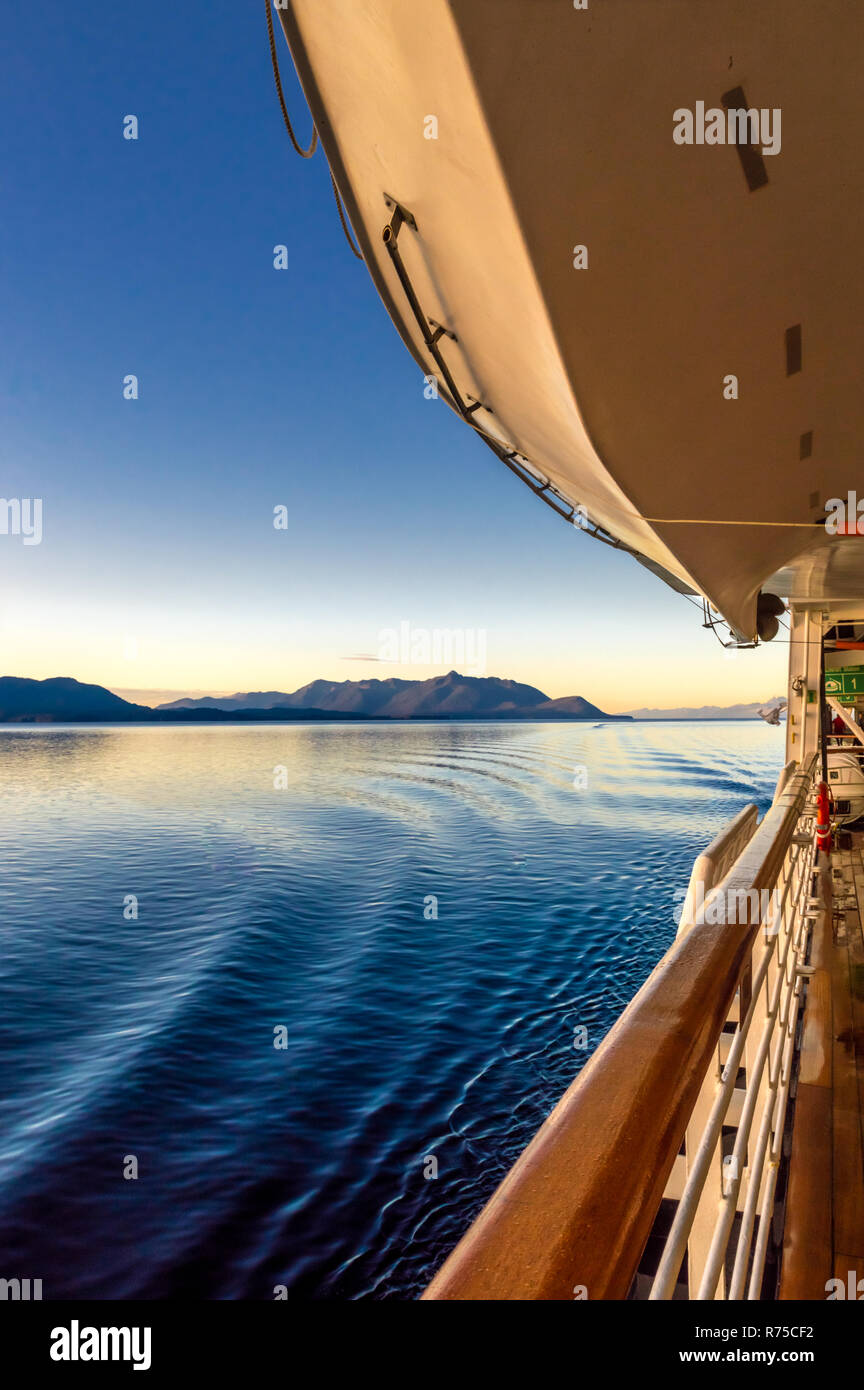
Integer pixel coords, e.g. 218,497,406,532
281,0,864,637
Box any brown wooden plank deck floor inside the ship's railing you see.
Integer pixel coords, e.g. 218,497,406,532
779,831,864,1300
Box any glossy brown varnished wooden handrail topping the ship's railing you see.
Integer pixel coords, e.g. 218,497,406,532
424,758,815,1301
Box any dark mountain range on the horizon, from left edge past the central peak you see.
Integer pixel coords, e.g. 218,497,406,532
0,671,626,724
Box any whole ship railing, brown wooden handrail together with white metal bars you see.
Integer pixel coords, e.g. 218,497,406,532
424,756,831,1300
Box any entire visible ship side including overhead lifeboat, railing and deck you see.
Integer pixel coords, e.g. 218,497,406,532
274,0,864,1300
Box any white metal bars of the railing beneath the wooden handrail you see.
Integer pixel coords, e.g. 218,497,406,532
650,760,815,1300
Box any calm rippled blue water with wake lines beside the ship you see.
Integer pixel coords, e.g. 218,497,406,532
0,723,783,1298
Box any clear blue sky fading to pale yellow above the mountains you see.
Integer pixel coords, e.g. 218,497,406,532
0,0,788,710
